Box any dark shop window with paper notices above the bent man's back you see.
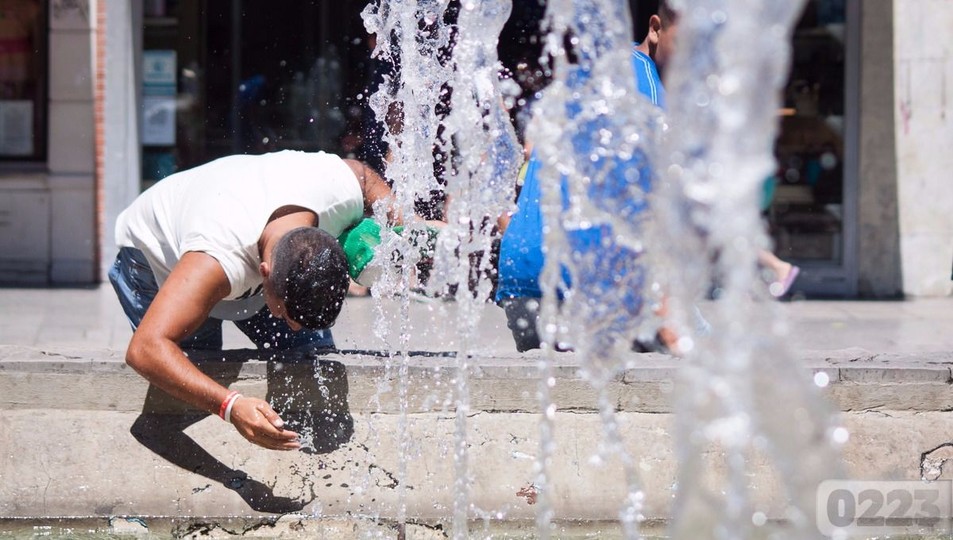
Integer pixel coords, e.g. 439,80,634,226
141,0,370,186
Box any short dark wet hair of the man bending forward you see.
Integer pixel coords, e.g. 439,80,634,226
269,227,349,329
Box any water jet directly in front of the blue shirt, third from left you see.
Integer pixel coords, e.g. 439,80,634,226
528,0,663,538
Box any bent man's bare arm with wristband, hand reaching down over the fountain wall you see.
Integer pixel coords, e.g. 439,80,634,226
126,252,300,450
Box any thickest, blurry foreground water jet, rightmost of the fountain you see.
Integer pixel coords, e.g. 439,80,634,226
658,0,841,538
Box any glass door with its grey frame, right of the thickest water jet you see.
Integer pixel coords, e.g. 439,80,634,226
763,0,860,296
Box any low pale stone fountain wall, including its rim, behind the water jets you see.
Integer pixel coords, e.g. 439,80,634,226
0,346,953,530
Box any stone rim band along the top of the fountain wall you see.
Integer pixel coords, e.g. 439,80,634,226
0,346,953,413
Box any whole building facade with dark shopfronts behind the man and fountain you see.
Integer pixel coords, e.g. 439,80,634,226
0,0,953,298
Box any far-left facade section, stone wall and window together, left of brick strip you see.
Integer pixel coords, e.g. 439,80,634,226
0,0,101,284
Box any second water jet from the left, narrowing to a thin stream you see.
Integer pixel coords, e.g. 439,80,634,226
428,0,522,539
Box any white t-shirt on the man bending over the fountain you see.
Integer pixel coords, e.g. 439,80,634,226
116,150,364,320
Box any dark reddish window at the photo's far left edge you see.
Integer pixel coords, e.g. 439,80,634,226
0,0,47,161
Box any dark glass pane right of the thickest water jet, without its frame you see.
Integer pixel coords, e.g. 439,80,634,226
765,0,847,264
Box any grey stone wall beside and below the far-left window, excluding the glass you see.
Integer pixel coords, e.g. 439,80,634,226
0,0,98,285
